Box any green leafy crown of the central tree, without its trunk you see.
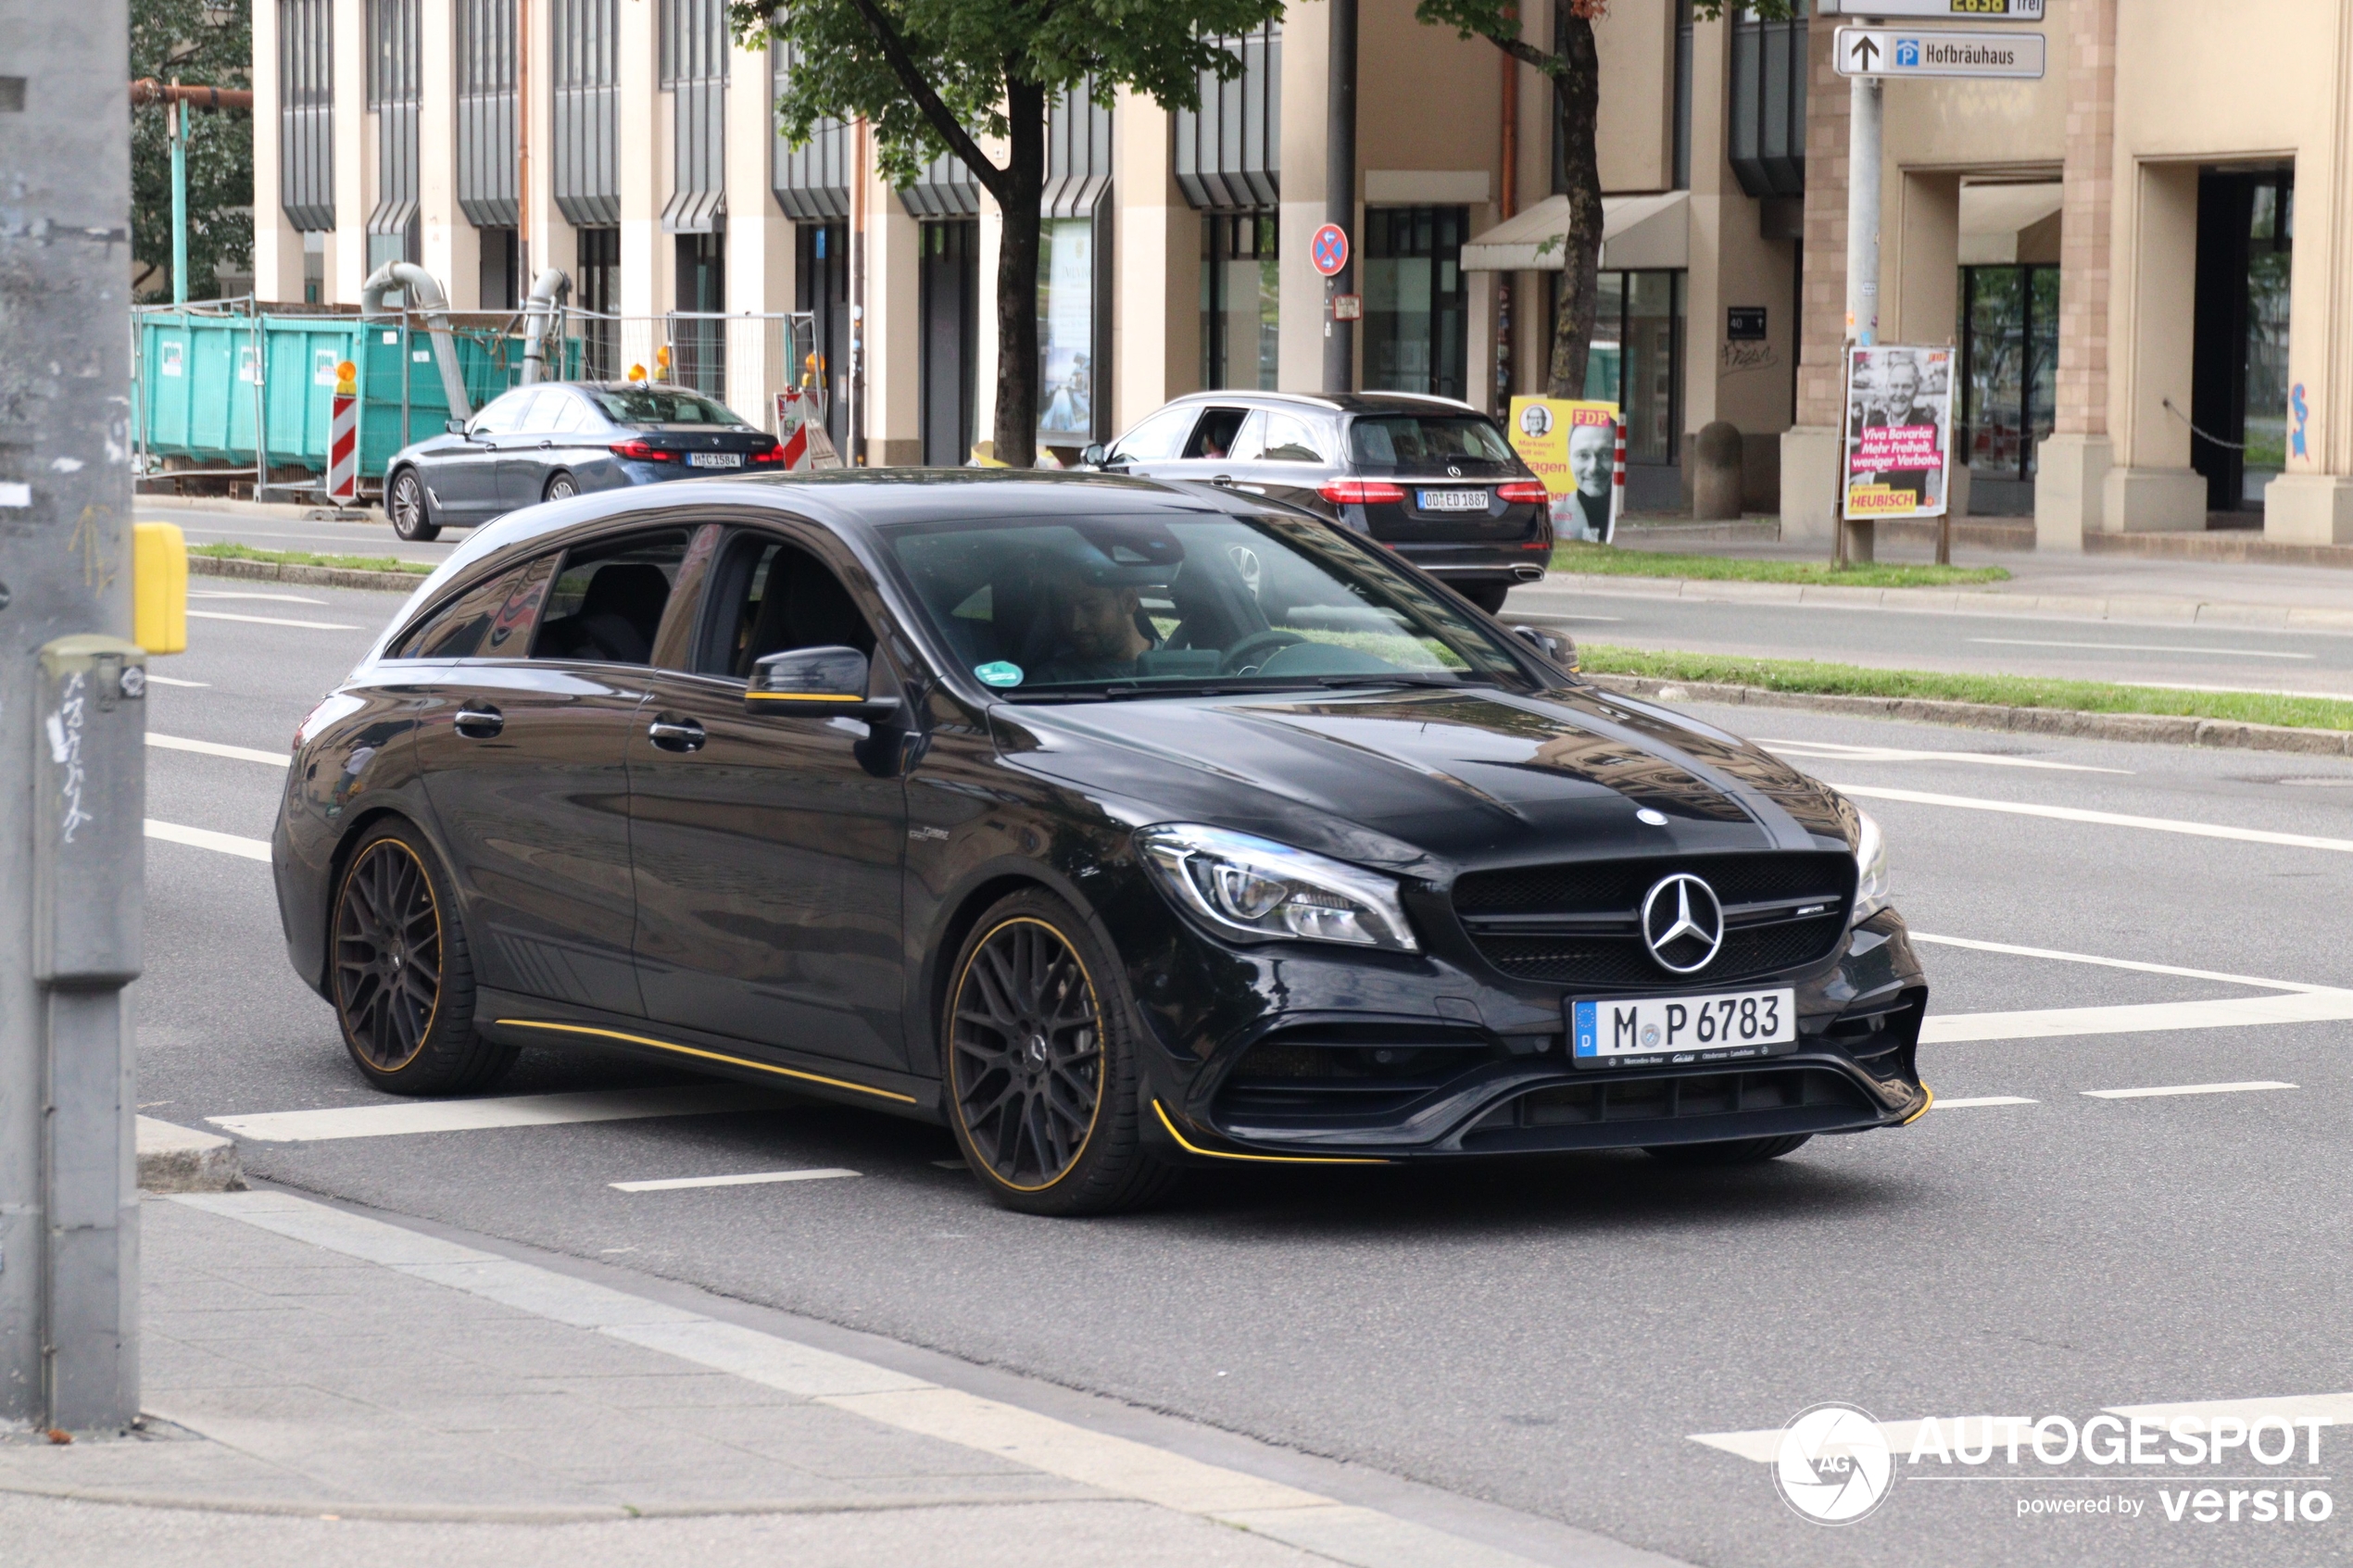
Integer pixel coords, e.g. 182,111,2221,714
727,0,1282,183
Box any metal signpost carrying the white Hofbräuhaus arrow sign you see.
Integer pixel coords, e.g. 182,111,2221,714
1814,0,2047,564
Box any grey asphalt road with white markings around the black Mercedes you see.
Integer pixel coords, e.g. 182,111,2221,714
134,583,2353,1568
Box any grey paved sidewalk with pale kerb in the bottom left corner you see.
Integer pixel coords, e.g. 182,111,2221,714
0,1192,1664,1568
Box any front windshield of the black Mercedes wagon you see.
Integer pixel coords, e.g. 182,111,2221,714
880,515,1534,700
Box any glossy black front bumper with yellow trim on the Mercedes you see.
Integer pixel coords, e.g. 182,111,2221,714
1139,912,1930,1163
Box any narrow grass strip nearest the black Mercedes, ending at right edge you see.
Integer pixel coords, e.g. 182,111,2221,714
1577,642,2353,729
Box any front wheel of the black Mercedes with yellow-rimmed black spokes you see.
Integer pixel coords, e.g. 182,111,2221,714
941,888,1176,1215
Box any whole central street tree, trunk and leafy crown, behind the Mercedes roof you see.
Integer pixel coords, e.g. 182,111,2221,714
729,0,1282,468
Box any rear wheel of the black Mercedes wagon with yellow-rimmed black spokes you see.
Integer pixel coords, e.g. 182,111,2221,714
327,822,518,1096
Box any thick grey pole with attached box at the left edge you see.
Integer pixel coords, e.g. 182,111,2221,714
0,0,145,1432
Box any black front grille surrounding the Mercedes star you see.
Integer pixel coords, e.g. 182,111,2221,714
1454,851,1855,987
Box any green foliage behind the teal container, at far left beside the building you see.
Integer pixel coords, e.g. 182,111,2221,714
125,0,254,298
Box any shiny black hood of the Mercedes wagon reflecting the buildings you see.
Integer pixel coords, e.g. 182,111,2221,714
990,686,1847,868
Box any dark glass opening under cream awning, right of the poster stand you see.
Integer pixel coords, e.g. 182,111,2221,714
1956,266,2059,517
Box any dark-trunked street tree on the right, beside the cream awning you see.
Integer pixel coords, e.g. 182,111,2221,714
1415,0,1803,397
